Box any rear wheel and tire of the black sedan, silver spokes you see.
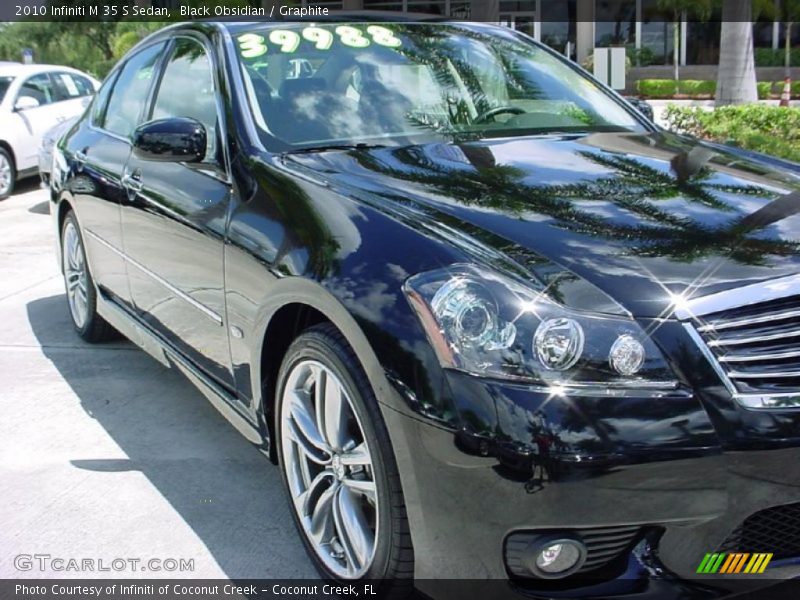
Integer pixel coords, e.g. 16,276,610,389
61,211,116,343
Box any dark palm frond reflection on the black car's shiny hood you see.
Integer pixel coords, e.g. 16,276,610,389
355,144,800,265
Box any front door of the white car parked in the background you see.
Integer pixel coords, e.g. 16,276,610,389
13,73,62,171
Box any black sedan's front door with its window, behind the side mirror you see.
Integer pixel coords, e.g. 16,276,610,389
122,37,233,385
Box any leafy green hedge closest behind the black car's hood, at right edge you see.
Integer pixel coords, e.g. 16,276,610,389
664,104,800,162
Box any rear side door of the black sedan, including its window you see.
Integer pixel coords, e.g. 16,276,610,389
65,42,166,305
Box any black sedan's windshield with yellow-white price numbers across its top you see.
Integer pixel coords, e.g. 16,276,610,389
235,23,643,151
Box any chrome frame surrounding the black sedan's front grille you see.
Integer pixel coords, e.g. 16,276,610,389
674,274,800,410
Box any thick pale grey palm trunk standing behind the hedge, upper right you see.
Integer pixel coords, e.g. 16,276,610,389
715,0,758,106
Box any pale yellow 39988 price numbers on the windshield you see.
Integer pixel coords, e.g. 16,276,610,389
237,25,403,58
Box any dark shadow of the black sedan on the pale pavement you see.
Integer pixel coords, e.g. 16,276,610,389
27,294,316,578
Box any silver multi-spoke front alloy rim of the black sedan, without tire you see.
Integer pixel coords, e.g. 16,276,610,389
281,360,379,579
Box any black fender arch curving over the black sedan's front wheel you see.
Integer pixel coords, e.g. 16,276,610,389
250,277,392,460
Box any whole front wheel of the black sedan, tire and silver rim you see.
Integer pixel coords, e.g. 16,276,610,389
275,323,414,597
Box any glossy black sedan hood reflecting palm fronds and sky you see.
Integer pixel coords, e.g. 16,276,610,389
286,132,800,317
